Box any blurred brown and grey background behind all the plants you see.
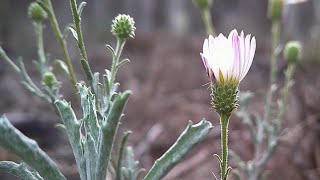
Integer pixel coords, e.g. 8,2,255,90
0,0,320,180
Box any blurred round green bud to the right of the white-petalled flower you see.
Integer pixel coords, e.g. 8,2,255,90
283,41,302,64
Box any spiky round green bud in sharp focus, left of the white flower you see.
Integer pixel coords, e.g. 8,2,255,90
111,14,136,39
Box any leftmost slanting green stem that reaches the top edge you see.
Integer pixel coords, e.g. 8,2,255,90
39,0,77,88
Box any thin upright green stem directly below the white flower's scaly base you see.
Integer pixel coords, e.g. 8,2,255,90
220,115,230,180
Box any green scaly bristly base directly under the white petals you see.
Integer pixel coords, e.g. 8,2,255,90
210,83,239,116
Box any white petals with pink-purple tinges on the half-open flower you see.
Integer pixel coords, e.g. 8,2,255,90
200,30,256,85
